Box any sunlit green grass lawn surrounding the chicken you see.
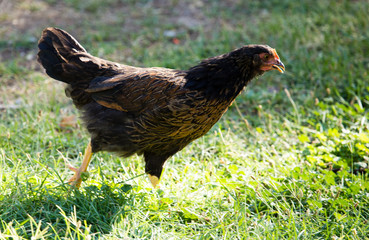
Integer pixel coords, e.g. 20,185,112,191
0,0,369,239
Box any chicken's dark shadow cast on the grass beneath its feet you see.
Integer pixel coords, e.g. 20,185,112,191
0,181,138,238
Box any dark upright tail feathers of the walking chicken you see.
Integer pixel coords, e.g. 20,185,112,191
37,27,119,107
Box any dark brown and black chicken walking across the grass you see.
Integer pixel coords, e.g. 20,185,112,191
38,27,285,187
